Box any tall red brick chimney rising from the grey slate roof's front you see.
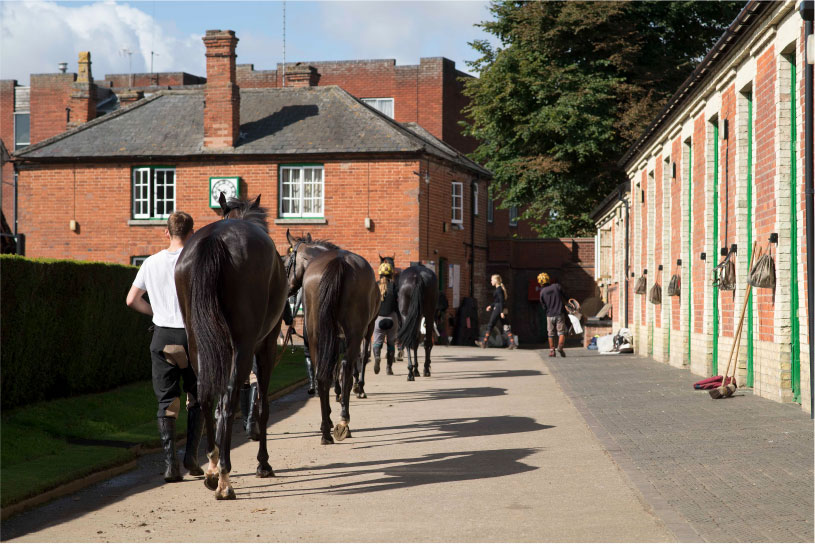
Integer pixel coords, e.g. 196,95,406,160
204,30,241,148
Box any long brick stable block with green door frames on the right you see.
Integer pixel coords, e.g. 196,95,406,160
594,1,811,411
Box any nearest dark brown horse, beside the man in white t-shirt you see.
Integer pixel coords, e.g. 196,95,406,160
175,193,287,499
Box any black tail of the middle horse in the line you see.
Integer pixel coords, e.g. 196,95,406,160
316,258,348,380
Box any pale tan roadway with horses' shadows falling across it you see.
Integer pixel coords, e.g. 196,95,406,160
2,346,675,542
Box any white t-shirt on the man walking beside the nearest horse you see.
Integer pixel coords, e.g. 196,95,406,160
133,249,184,329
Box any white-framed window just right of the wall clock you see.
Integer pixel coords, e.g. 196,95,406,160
279,164,324,217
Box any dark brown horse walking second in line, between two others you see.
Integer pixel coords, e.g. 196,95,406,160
286,231,379,444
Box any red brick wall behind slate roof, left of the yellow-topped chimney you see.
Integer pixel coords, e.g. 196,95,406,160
31,74,76,144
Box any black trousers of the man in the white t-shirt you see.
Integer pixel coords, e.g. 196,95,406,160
150,326,198,417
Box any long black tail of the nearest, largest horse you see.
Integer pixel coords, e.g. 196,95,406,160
190,236,232,400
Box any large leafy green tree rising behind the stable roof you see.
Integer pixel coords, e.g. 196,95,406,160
464,1,743,236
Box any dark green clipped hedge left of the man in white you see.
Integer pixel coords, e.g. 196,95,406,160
0,255,151,409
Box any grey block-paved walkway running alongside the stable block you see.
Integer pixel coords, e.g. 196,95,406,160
541,349,813,542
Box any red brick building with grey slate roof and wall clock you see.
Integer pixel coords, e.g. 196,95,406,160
14,31,490,314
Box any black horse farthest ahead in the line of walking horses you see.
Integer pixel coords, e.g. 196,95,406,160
397,265,439,382
